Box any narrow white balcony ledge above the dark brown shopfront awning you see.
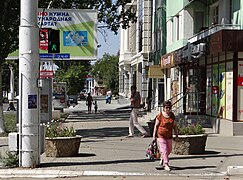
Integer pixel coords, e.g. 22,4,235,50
188,24,240,44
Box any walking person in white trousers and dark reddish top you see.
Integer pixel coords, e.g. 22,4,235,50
127,86,147,137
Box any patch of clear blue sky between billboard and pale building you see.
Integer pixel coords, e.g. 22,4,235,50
97,30,120,59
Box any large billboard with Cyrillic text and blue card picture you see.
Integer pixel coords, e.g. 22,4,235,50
9,9,98,60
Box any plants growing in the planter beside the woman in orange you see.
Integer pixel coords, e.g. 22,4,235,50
178,118,205,135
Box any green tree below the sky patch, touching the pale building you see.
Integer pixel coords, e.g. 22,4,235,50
92,54,119,95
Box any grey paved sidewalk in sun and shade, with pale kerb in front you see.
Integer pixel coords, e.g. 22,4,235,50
0,97,243,179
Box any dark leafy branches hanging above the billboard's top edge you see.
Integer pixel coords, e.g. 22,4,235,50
39,0,137,34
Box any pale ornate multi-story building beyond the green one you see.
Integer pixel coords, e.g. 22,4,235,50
119,0,152,102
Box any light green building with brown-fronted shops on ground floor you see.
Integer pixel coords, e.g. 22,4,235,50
160,0,243,135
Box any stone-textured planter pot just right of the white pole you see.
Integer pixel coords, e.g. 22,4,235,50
45,136,81,157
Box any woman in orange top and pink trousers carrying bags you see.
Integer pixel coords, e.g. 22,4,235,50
153,101,178,171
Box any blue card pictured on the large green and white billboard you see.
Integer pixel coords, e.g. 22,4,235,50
63,31,88,46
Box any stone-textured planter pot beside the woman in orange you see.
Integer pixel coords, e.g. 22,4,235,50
173,134,207,155
